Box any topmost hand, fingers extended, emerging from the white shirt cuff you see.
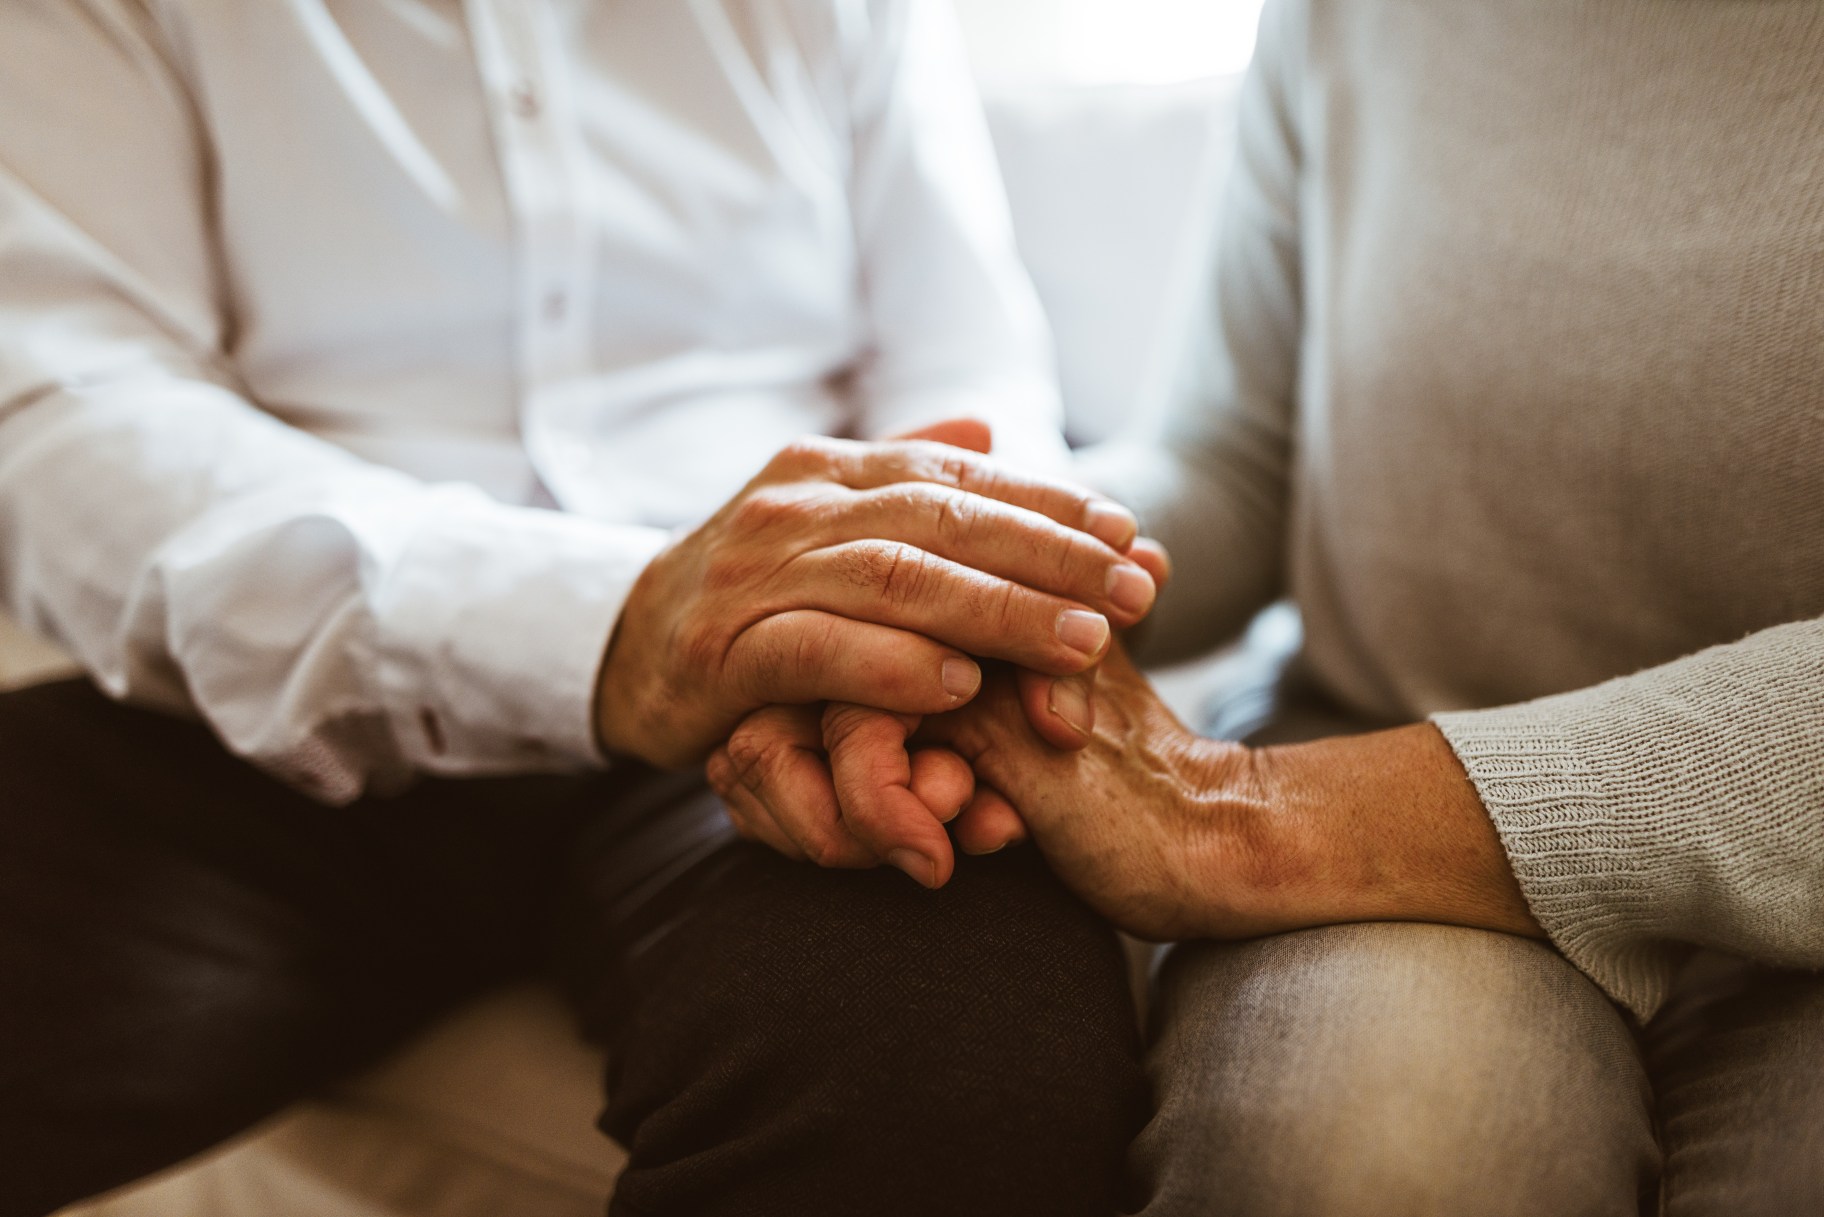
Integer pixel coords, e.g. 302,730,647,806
596,423,1155,768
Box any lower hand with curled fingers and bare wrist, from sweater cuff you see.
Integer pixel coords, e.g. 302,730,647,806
718,644,1541,941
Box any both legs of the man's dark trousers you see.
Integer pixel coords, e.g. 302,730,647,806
0,684,1144,1217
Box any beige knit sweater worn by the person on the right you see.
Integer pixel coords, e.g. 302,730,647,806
1093,0,1824,1018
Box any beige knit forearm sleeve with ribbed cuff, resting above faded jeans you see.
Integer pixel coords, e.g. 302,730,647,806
1434,619,1824,1020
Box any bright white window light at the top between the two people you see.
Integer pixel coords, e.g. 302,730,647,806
956,0,1262,84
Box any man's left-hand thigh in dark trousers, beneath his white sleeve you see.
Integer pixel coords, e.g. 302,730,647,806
0,682,656,1213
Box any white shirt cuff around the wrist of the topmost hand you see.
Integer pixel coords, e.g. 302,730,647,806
362,498,668,775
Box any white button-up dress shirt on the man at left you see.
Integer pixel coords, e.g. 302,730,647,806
0,0,1062,801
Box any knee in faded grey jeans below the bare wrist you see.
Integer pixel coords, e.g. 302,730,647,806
1135,925,1656,1217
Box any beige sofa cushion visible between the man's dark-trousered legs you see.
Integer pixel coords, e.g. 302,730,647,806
64,985,626,1217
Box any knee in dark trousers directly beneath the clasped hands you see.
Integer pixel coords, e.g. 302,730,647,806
609,854,1145,1213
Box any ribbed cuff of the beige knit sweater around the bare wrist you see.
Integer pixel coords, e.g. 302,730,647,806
1432,699,1682,1022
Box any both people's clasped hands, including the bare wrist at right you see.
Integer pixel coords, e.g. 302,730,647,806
596,421,1538,940
